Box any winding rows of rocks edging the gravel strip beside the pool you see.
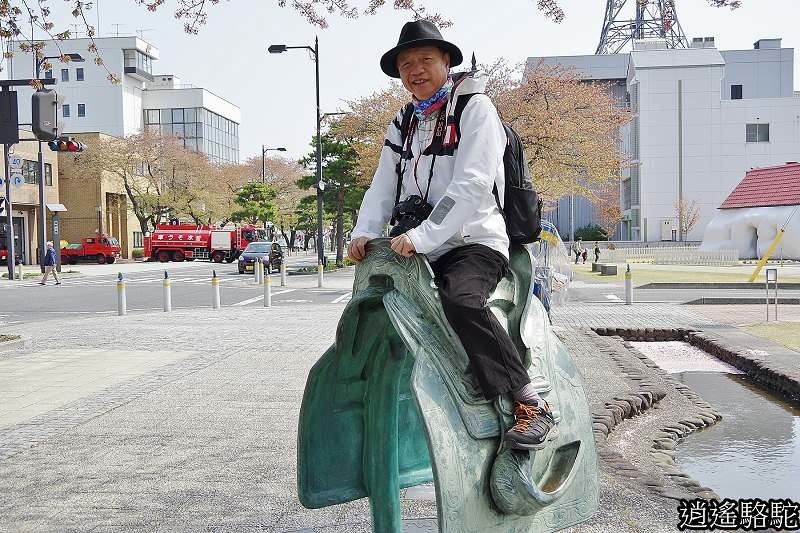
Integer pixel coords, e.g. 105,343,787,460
592,328,722,499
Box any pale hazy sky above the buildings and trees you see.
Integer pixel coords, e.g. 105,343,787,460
39,0,800,160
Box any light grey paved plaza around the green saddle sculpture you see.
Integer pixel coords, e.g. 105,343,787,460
0,284,792,533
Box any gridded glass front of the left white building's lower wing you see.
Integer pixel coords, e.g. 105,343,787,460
144,107,239,163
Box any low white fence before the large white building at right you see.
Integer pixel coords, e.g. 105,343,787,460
600,246,739,266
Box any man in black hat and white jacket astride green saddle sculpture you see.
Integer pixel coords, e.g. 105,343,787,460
348,20,555,450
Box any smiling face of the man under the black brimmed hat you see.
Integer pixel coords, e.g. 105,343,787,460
397,46,450,100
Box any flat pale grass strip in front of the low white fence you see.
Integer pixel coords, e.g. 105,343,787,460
572,262,800,286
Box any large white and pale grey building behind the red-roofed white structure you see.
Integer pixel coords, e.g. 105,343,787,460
528,38,800,241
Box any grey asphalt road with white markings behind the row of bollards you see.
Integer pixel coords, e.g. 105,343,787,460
0,252,352,327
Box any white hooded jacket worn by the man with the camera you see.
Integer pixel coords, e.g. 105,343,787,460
352,73,509,261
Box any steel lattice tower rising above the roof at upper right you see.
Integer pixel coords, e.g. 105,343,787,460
595,0,689,54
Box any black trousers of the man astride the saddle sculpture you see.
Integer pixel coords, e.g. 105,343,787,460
431,244,530,400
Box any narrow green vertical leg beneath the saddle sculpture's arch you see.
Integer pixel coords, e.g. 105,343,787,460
364,338,405,533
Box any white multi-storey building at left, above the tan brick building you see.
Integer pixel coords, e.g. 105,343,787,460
8,37,241,163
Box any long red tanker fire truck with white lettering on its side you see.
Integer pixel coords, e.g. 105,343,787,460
144,224,266,263
